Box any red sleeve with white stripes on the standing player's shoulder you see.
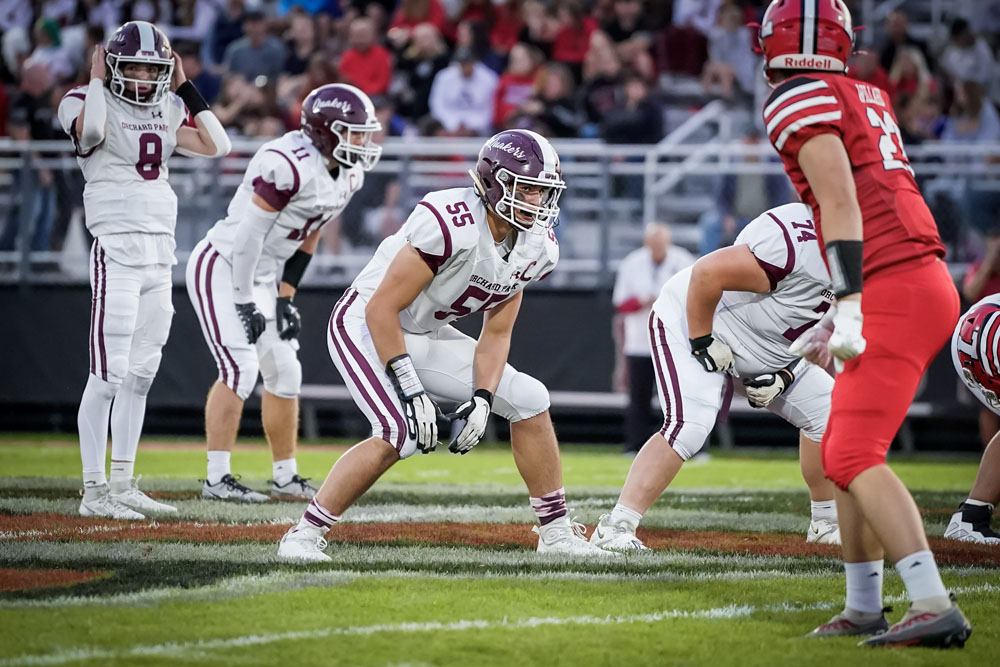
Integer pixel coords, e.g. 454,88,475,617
764,76,844,158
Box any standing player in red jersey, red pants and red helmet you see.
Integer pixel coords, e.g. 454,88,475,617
760,0,972,646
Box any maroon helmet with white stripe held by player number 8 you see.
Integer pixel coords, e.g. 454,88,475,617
104,21,174,106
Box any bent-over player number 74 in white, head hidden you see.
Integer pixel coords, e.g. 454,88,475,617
590,204,840,551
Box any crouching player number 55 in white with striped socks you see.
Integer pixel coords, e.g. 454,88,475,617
278,130,608,561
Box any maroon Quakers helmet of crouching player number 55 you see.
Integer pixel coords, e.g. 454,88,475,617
469,130,566,231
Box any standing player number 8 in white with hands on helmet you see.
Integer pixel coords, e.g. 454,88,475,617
59,21,230,519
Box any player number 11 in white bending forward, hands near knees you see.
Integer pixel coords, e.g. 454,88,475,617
187,84,382,502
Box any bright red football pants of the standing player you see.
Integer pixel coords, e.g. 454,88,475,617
822,261,959,491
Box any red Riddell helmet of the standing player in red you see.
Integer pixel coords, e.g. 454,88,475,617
758,0,854,81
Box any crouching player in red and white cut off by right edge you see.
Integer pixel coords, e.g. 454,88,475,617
944,294,1000,546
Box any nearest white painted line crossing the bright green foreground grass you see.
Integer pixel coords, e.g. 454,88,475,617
7,583,1000,667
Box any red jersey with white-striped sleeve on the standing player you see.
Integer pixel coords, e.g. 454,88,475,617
764,72,944,278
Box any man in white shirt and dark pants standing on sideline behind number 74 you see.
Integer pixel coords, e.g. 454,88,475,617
612,222,694,454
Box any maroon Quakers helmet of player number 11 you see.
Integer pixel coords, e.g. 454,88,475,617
301,83,382,171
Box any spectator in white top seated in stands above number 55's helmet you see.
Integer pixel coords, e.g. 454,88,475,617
430,48,499,136
